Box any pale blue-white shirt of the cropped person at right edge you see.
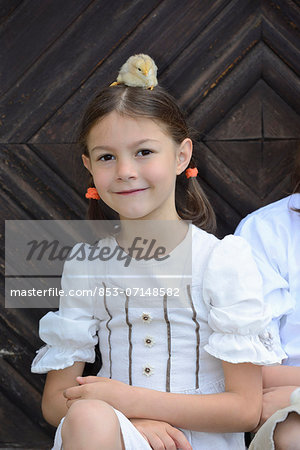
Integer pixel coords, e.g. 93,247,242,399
235,194,300,366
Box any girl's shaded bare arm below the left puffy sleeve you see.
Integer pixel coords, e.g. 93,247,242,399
42,362,85,427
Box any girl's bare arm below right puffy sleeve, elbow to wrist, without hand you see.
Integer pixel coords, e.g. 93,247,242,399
133,362,262,433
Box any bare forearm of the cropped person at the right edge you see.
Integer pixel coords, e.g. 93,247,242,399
263,365,300,388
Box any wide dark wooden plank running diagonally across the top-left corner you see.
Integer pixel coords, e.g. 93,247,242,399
0,0,91,95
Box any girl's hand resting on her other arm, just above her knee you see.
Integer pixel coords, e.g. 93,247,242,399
63,376,135,417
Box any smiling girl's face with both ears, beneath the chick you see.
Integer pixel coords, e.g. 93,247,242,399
82,111,192,220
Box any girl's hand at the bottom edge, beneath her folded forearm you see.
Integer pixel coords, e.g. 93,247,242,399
131,419,193,450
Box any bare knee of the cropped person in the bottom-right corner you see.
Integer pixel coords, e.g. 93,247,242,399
274,412,300,450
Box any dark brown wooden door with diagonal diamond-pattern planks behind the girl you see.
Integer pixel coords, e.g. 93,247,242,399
0,0,300,450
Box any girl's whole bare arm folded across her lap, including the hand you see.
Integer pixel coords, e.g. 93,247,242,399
65,362,262,433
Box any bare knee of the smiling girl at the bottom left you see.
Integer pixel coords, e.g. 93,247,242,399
61,400,125,450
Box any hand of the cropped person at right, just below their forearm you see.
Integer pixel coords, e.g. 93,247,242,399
254,386,299,432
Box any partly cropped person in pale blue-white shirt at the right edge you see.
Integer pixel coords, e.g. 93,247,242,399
235,165,300,450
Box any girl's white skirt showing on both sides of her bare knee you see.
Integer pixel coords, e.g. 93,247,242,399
52,408,152,450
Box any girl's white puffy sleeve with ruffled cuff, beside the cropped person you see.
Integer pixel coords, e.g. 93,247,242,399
203,235,286,365
